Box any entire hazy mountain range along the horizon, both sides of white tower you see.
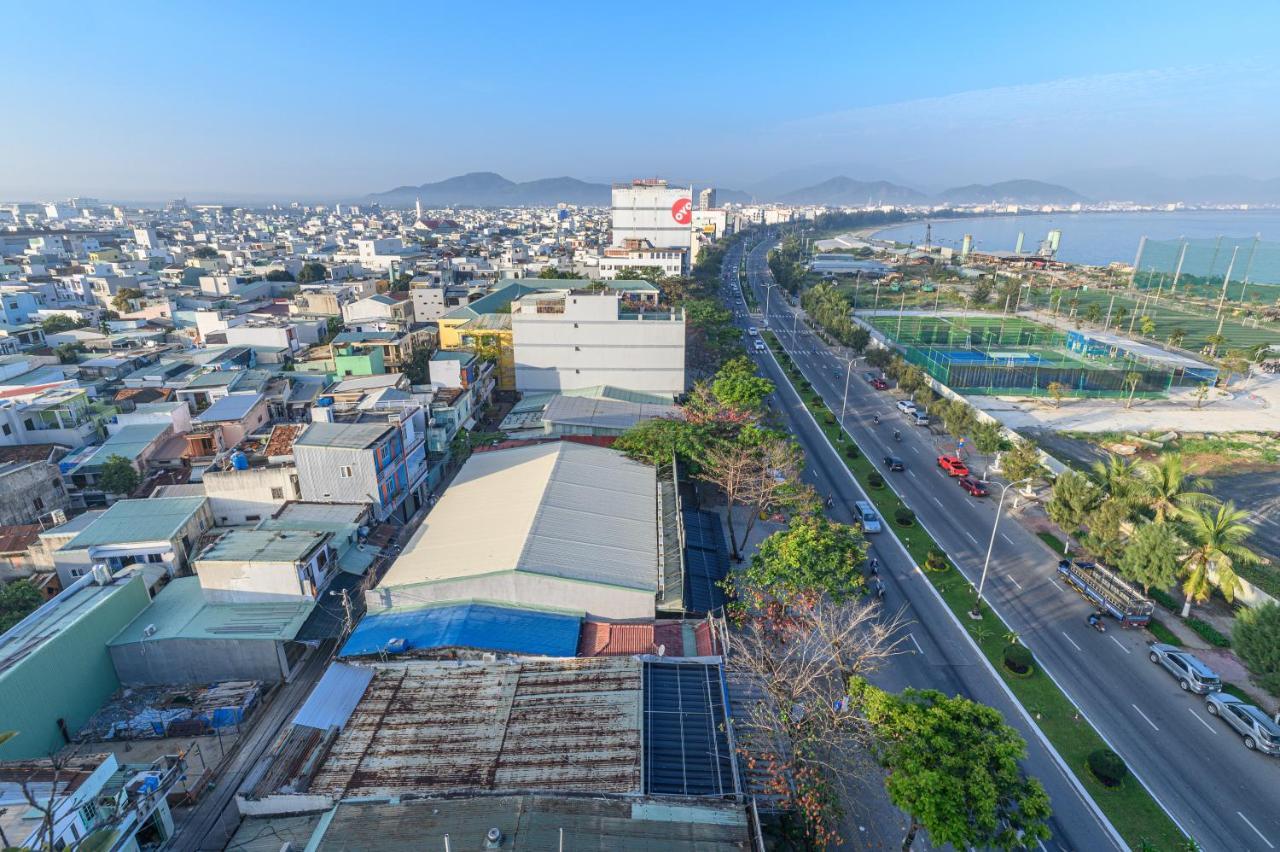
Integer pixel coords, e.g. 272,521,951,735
362,170,1280,207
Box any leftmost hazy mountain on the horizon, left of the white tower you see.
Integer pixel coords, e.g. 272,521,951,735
365,171,609,207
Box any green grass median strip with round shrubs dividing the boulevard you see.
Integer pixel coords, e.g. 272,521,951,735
762,330,1187,851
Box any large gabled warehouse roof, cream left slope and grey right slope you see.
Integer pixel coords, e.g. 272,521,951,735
381,441,658,591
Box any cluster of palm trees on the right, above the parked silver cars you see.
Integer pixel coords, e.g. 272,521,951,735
1091,453,1258,618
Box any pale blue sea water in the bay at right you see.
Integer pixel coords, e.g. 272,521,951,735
876,210,1280,283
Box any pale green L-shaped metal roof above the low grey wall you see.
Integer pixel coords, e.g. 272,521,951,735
108,577,315,646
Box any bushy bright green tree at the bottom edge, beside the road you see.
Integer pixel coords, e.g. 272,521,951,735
849,678,1051,852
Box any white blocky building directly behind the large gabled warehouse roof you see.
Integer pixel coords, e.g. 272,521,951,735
511,290,685,394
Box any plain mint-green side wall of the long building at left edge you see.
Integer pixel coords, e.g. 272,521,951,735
0,572,151,760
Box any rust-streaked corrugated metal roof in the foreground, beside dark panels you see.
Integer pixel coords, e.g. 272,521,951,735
308,658,641,800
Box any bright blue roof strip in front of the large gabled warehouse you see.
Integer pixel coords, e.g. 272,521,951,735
340,604,582,656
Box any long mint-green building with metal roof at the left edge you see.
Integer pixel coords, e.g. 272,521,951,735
0,571,151,757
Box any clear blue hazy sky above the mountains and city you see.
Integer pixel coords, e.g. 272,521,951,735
0,0,1280,200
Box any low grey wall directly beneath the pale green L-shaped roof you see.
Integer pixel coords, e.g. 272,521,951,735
108,638,288,686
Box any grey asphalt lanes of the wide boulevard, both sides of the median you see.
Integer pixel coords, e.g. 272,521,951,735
726,232,1280,852
